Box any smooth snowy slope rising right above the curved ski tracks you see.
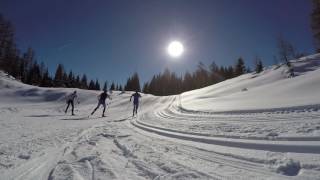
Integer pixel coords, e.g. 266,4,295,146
181,55,320,112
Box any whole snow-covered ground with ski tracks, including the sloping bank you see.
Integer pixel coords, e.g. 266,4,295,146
0,55,320,180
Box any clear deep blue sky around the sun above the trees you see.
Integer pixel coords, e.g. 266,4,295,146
0,0,314,83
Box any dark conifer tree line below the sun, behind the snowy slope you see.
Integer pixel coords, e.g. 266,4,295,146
142,58,250,96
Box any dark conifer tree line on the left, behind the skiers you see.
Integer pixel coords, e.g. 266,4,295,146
0,14,112,90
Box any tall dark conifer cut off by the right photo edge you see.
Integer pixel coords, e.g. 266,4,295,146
311,0,320,53
